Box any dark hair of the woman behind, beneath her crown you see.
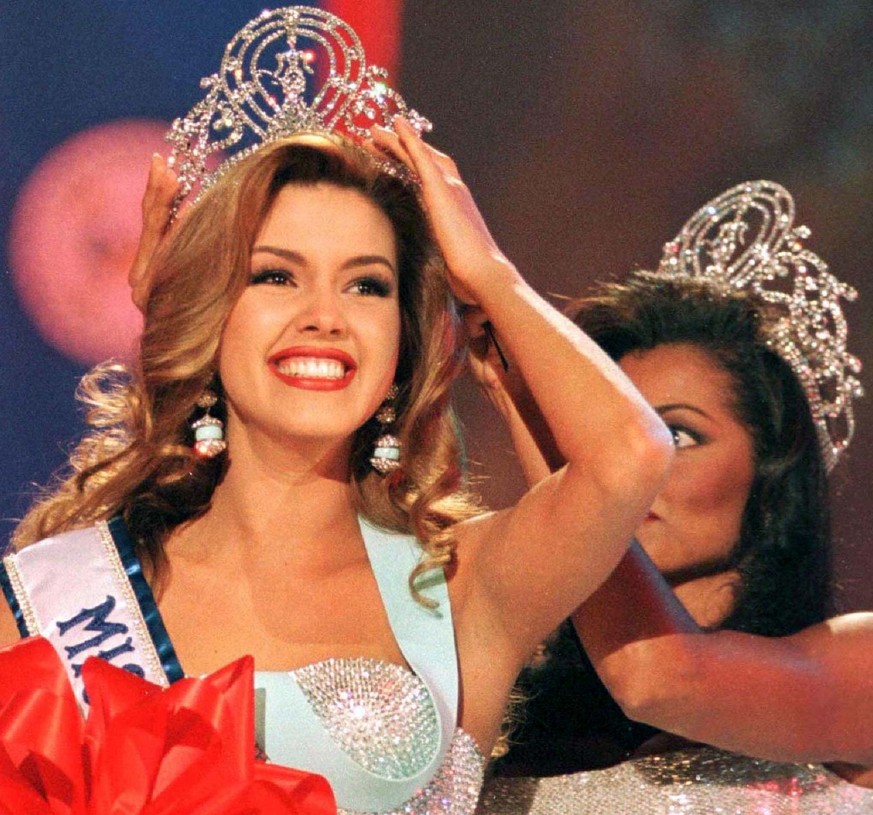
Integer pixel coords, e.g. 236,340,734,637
570,272,831,636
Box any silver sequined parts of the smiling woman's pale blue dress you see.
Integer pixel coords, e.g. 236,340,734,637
294,659,485,815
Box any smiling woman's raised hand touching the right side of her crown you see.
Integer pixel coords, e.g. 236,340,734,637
372,118,516,305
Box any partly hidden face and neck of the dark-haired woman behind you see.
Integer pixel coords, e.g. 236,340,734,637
619,344,754,626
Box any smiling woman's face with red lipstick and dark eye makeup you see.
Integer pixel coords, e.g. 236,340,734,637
219,183,400,450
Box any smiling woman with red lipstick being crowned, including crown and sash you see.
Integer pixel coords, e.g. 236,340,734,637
0,7,673,815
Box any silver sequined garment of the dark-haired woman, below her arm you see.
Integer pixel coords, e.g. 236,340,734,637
476,747,873,815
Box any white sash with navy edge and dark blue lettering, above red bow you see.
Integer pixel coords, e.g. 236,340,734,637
0,518,183,706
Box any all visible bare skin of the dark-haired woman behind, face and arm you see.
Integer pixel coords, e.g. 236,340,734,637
474,340,873,787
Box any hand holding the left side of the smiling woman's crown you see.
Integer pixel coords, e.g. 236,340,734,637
127,153,179,311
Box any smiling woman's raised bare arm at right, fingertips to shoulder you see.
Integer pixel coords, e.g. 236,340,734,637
377,123,672,662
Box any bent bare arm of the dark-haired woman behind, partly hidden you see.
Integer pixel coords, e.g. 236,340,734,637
476,342,873,772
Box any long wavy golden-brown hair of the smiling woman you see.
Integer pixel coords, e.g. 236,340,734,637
13,135,479,604
